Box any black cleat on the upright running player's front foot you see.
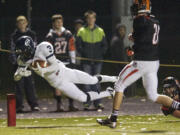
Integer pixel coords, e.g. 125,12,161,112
96,118,117,128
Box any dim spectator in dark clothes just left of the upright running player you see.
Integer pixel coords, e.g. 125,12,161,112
110,24,127,74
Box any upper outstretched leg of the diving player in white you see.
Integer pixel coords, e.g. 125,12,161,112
62,68,118,84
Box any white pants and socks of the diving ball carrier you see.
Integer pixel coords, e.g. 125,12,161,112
56,68,111,102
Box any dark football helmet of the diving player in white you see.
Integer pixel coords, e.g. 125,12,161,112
16,36,35,60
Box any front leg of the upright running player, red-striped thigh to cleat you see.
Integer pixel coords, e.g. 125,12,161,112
97,62,142,128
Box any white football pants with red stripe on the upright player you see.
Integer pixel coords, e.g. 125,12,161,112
115,61,159,102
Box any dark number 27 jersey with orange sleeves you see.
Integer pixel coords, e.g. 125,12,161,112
46,30,75,62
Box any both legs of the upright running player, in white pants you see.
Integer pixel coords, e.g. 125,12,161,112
97,63,180,128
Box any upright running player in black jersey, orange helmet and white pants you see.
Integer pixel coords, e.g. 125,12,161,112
97,0,180,128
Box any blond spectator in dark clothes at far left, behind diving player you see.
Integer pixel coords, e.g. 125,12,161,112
10,16,40,113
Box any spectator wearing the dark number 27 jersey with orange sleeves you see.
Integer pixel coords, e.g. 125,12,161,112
46,14,78,112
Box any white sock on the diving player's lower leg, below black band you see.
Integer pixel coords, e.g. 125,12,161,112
88,91,111,101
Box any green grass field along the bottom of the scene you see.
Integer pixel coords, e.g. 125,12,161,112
0,115,180,135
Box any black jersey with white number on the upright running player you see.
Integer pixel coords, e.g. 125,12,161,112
132,16,160,61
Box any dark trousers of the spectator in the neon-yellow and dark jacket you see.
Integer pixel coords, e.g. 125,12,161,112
82,63,102,107
